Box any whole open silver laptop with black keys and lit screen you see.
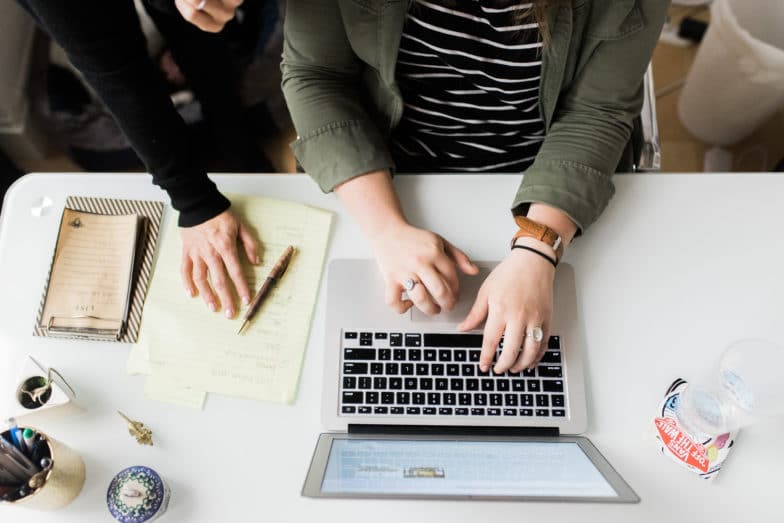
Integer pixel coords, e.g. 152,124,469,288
302,259,639,503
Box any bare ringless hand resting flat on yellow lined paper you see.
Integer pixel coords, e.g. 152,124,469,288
180,210,260,318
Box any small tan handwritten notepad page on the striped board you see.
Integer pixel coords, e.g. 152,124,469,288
41,209,140,332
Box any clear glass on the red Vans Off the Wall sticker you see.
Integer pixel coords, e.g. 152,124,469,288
678,339,784,436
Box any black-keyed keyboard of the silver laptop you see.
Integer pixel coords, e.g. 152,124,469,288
339,330,568,418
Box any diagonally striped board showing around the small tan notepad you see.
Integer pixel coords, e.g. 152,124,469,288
33,196,165,343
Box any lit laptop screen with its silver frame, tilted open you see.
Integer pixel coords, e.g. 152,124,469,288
302,433,640,503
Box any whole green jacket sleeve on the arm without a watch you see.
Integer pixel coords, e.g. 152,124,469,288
281,0,393,192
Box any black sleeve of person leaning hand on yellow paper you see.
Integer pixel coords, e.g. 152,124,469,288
19,0,230,227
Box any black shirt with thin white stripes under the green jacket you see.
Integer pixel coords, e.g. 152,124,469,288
392,0,544,172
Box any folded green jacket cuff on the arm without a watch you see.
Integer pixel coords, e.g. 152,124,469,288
291,120,394,192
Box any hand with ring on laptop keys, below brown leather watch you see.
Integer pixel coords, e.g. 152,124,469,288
457,249,555,374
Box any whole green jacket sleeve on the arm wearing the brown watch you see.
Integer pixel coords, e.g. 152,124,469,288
513,0,669,231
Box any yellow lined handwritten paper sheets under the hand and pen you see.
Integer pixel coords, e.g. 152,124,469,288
129,195,332,406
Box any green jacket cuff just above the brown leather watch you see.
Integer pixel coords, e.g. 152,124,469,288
512,160,615,234
